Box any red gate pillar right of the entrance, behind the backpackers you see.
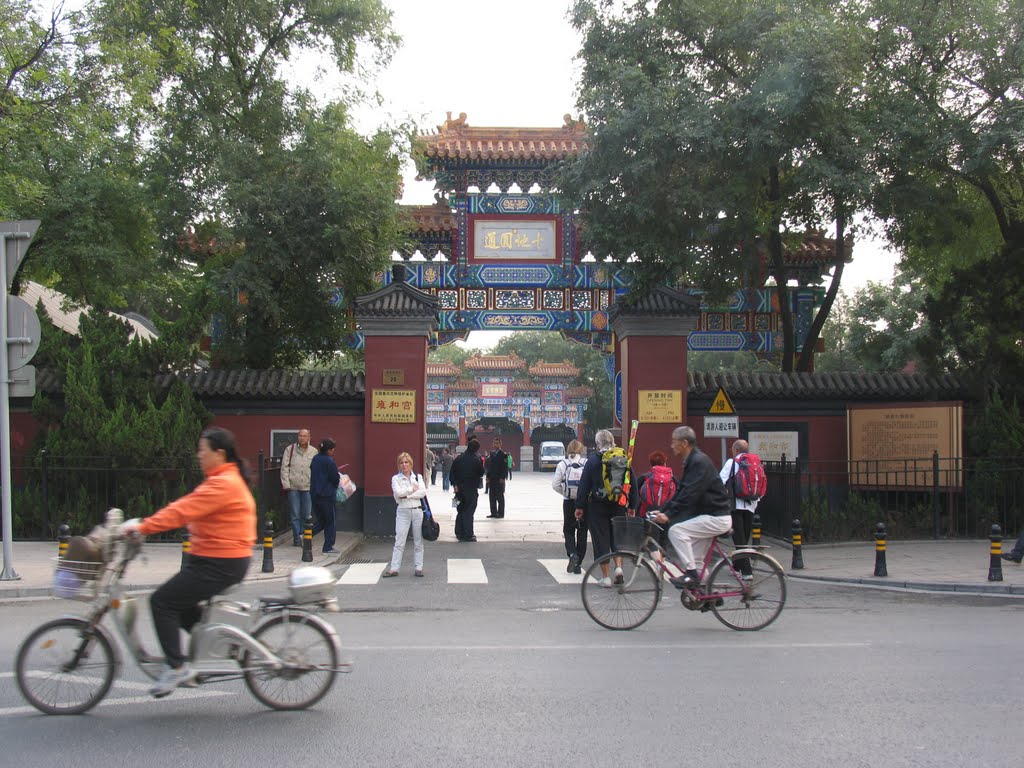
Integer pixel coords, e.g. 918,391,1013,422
608,286,700,474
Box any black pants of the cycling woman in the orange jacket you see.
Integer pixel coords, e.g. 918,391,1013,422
150,555,250,667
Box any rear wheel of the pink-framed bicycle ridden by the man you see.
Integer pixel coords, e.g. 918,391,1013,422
708,552,785,632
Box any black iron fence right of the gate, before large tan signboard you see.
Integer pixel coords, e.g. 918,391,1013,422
758,454,1024,543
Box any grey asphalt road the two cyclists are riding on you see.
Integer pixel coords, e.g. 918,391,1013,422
0,540,1024,768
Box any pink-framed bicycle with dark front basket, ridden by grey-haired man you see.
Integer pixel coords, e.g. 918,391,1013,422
581,517,785,632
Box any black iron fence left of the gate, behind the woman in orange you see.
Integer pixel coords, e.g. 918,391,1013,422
11,451,289,541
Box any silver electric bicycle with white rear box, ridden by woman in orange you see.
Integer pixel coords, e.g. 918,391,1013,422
15,510,351,715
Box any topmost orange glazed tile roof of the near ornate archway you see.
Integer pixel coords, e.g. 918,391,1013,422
414,113,590,161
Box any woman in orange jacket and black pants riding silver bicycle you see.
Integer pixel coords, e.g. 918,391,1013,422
122,427,256,698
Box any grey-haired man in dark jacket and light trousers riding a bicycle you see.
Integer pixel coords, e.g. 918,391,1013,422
653,427,732,589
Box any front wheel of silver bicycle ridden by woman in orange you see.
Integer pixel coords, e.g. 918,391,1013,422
14,618,117,715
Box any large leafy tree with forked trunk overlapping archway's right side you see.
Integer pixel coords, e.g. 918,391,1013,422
562,0,872,371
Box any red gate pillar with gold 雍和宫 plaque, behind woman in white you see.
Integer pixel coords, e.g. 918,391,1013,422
354,264,437,536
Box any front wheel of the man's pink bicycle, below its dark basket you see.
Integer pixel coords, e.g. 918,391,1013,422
582,552,662,630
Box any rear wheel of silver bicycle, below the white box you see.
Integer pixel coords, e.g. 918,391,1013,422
242,613,338,710
